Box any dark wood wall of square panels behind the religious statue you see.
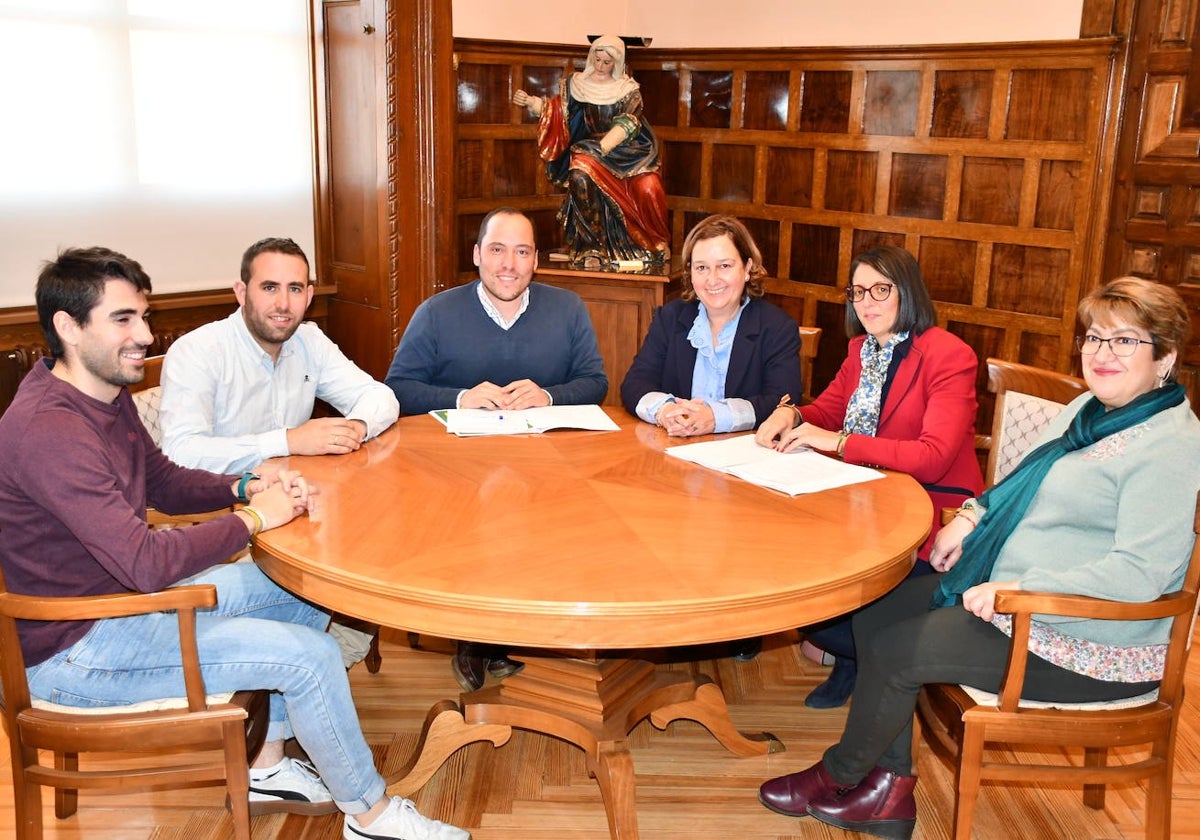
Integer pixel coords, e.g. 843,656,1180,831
456,38,1118,417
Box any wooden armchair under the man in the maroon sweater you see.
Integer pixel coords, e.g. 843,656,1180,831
0,564,269,840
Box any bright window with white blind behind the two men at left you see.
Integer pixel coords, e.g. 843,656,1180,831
0,0,313,306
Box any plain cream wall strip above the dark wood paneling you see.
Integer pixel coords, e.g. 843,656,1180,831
454,0,1084,48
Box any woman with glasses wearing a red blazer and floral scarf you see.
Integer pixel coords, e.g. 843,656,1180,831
756,246,983,708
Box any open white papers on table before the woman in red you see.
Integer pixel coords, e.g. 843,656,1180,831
666,434,883,496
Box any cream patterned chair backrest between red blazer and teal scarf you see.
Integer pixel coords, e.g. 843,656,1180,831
984,359,1087,486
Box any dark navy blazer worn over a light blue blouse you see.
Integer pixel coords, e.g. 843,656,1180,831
620,298,803,426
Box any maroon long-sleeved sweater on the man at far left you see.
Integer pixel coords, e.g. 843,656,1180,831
0,362,248,667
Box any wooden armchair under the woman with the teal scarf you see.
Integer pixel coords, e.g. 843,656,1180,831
917,497,1200,840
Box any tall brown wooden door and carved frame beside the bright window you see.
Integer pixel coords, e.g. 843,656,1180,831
312,0,455,378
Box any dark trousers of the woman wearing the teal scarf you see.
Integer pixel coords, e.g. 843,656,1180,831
824,575,1157,785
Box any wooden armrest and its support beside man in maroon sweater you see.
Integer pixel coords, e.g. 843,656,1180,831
0,583,217,712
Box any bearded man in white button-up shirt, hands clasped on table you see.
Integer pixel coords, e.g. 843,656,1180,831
161,239,400,667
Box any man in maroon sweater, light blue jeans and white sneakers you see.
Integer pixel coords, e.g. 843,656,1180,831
0,248,468,840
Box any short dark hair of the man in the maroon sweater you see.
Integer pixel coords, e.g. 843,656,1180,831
34,246,150,359
